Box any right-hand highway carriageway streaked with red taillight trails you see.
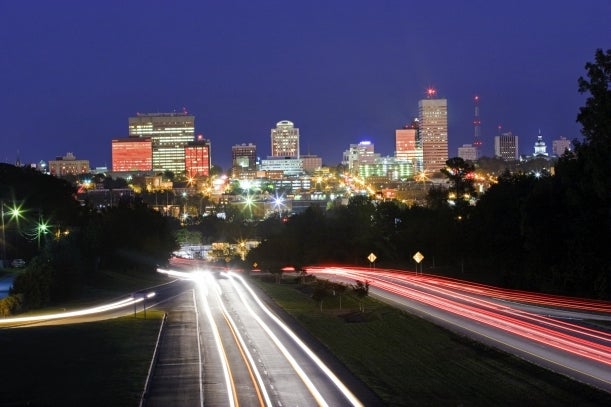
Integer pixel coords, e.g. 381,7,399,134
307,267,611,392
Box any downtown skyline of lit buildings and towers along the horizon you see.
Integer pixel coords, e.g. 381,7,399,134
34,89,571,188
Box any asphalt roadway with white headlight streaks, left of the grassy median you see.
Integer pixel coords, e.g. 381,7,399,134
143,271,382,407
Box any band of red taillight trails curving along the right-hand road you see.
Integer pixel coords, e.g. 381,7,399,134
307,267,611,390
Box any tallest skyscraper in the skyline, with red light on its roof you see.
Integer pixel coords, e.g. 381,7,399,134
418,89,448,172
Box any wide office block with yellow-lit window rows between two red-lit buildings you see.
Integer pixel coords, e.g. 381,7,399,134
129,111,195,174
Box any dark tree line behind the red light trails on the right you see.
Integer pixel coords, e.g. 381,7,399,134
248,50,611,299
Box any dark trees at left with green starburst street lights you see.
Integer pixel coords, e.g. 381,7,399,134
0,163,179,315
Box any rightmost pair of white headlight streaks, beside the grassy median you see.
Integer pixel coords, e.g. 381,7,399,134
228,272,363,406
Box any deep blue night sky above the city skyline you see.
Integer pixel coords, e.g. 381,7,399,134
0,0,611,169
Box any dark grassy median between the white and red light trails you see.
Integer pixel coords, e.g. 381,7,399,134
260,283,611,407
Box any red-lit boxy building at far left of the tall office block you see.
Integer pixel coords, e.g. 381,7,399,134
112,137,153,172
